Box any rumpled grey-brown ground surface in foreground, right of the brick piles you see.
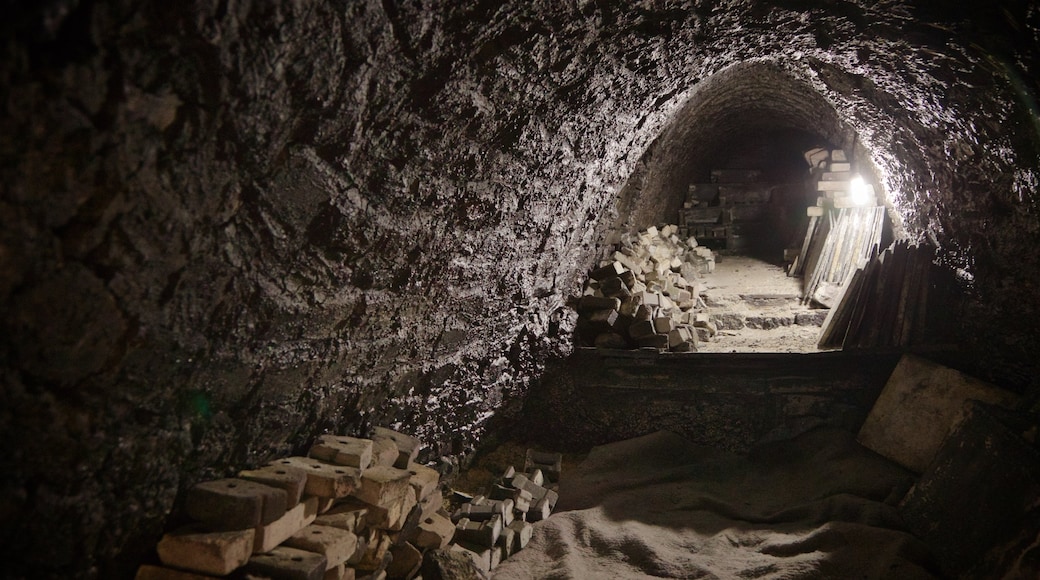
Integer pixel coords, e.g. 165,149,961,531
493,429,935,580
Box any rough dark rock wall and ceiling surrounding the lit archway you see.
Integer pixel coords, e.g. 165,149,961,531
0,0,1040,578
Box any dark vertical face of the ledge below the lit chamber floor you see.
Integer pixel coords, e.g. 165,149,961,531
525,348,899,451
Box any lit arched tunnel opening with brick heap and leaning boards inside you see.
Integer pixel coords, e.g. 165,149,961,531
579,61,893,352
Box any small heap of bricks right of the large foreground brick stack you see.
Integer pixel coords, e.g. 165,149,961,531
451,449,563,573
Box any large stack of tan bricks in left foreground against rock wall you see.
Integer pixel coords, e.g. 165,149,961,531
136,427,447,580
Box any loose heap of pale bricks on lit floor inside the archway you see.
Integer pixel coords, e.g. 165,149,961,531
574,225,717,352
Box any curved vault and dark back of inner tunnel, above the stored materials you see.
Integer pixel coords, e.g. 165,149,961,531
606,60,892,262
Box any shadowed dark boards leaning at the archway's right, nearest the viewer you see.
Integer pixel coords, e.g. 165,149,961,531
820,241,935,350
